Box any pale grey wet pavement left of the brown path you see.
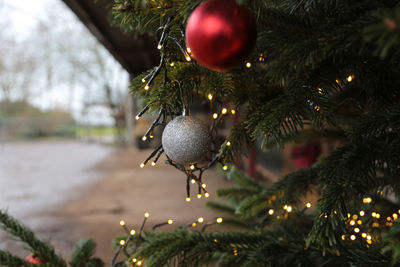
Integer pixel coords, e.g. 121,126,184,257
0,141,113,224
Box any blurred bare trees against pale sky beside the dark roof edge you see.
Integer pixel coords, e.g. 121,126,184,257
0,0,128,140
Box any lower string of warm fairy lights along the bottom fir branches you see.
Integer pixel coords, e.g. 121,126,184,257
110,197,400,267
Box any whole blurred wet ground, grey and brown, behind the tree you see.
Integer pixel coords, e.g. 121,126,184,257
0,142,231,263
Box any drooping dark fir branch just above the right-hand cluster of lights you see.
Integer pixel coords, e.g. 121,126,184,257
308,136,400,247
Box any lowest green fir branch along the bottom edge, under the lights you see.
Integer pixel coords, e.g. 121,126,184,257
135,226,330,266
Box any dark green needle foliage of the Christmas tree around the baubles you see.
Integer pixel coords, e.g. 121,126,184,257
109,0,400,266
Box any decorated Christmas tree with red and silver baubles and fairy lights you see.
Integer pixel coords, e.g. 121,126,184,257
0,0,400,266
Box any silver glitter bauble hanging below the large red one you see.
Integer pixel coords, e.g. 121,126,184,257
161,116,211,164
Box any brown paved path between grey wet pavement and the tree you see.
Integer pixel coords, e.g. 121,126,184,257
0,144,230,263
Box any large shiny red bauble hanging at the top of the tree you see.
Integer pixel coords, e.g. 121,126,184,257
186,0,257,71
